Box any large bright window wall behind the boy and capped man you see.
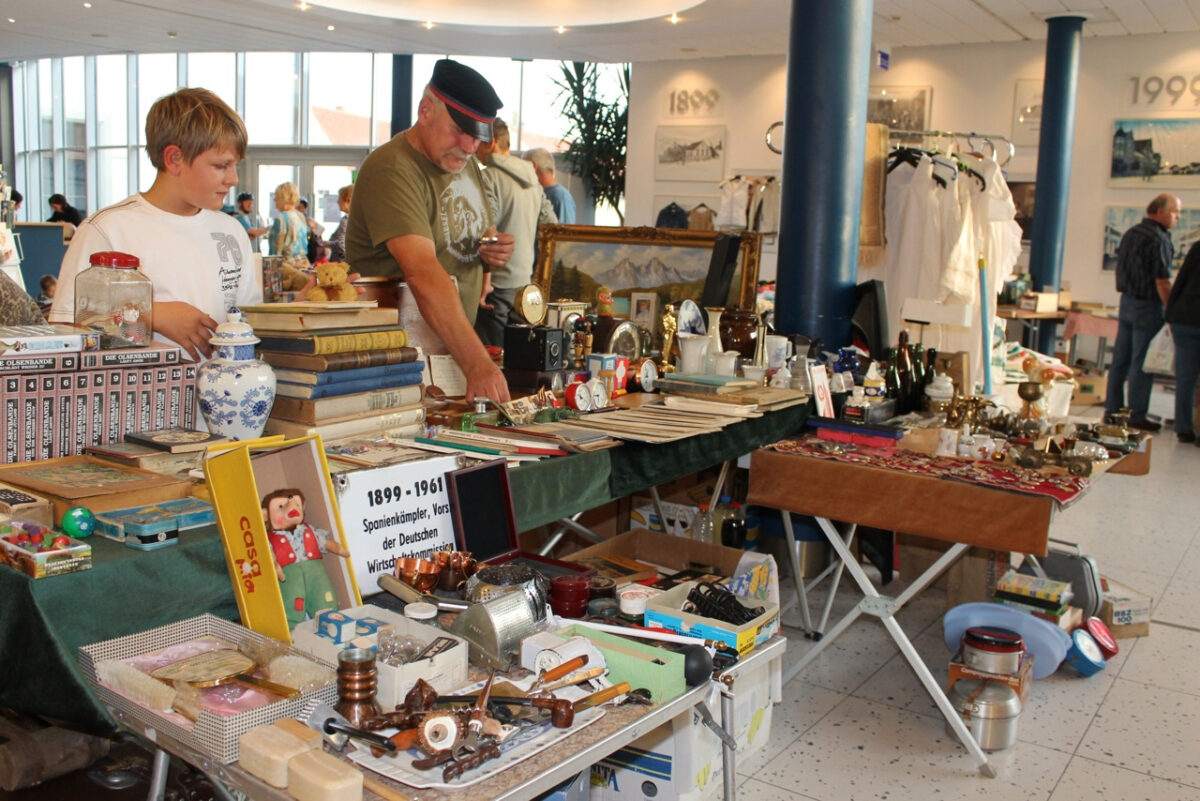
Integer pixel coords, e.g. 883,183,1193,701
10,53,628,223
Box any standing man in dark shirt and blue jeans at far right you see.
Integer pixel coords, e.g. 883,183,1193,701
1104,194,1183,432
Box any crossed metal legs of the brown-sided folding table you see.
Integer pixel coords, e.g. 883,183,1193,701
806,517,996,778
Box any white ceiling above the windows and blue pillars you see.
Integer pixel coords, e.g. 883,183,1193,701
0,0,1200,62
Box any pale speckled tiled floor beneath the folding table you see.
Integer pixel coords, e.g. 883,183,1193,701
738,393,1200,801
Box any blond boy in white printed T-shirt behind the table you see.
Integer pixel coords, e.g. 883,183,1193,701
49,89,263,359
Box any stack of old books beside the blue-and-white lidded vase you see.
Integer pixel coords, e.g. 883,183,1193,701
242,301,425,440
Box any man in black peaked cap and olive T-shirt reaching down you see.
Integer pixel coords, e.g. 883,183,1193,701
346,59,512,401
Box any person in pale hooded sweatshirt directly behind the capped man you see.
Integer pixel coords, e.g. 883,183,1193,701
475,118,558,347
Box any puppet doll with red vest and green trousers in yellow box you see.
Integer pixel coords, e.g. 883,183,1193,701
263,489,350,627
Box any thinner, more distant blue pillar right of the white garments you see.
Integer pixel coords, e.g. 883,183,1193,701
1030,14,1086,351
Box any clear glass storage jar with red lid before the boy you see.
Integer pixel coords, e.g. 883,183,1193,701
74,251,154,350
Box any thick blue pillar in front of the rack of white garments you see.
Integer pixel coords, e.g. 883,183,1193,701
775,0,875,348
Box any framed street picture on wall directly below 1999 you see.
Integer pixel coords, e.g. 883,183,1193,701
1109,116,1200,189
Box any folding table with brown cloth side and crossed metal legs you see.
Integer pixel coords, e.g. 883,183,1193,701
748,444,1086,776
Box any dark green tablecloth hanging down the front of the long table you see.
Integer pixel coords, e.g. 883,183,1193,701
0,406,805,729
